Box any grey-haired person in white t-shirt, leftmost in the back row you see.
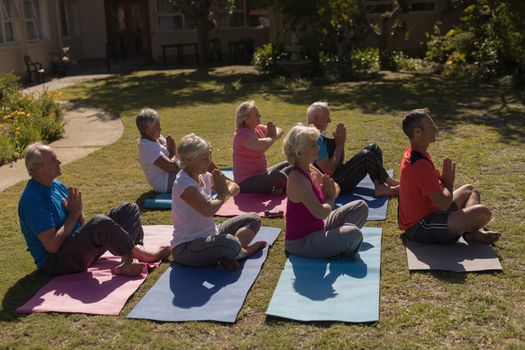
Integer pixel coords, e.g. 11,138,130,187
135,108,180,193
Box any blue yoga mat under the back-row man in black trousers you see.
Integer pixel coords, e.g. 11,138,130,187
334,169,394,221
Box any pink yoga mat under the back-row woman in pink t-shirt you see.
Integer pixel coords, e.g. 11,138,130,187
215,193,286,217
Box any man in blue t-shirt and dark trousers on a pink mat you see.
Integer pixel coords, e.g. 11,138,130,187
18,143,170,276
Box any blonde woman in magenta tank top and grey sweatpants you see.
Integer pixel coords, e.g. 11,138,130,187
284,124,368,258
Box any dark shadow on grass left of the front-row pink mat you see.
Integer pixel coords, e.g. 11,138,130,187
0,270,52,321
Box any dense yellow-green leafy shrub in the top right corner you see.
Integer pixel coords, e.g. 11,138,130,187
427,0,525,85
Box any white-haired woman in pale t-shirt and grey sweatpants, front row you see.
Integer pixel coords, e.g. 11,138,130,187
171,134,266,270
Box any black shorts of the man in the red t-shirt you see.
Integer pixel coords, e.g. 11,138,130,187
406,202,461,244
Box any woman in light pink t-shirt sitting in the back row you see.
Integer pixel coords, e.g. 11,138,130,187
233,100,288,195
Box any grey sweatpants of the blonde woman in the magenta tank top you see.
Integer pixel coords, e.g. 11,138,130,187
284,200,368,259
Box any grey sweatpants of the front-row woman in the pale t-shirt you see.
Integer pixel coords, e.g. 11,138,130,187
173,213,261,266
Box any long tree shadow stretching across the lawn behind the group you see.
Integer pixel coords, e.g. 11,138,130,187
67,70,525,143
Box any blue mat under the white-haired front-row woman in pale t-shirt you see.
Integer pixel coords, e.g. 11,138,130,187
128,227,281,323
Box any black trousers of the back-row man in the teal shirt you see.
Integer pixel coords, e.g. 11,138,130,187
323,137,388,193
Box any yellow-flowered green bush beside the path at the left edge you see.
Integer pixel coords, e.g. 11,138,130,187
0,74,64,165
